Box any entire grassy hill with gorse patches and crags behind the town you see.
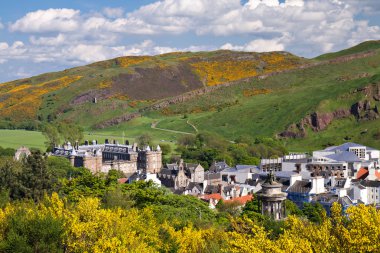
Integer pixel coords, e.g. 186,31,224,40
0,41,380,151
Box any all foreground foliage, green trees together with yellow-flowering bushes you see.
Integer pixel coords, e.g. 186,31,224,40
0,152,380,252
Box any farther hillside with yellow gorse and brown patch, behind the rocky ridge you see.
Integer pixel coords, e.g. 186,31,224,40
0,50,307,124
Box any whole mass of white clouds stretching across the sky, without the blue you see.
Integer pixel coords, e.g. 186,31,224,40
0,0,380,77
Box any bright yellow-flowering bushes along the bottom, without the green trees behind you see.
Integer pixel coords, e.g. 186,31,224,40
0,193,380,252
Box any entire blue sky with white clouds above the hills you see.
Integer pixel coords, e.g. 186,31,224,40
0,0,380,82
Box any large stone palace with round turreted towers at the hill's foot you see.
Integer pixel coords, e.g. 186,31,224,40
52,139,162,174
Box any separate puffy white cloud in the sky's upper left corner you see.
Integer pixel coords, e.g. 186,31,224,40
10,9,80,33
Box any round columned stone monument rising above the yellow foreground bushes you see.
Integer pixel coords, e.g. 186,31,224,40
257,171,288,220
